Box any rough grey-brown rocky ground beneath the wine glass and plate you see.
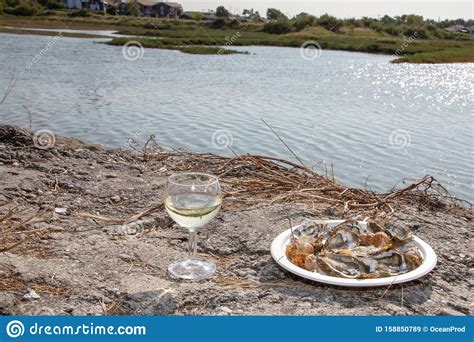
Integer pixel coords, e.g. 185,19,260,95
0,126,473,315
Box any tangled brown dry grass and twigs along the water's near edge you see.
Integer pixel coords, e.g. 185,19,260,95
140,148,470,215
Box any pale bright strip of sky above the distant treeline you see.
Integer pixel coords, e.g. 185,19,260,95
177,0,473,20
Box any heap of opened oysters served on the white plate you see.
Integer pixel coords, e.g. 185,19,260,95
286,220,423,279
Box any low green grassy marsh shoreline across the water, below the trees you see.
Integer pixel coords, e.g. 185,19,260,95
0,16,474,64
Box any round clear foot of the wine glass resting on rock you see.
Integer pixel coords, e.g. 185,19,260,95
168,259,216,280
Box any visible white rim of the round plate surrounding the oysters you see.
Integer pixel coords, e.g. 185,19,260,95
271,220,437,287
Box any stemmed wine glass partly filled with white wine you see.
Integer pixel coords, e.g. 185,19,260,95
163,173,222,280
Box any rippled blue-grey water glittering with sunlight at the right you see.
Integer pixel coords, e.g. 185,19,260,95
0,34,474,200
